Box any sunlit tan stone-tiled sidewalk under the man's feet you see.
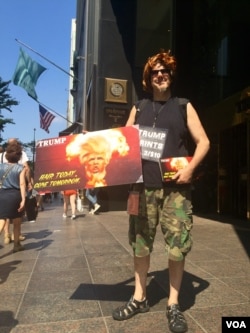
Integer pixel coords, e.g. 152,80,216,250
0,199,250,333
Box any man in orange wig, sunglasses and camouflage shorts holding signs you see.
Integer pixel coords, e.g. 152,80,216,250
113,51,209,333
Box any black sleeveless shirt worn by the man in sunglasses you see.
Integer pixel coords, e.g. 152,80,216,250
136,97,189,188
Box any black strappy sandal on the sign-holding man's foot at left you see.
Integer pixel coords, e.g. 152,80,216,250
112,296,150,321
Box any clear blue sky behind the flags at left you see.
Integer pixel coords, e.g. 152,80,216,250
0,0,76,156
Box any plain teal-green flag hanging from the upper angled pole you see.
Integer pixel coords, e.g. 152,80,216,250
12,48,46,100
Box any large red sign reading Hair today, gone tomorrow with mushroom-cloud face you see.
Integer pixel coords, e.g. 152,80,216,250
34,126,142,192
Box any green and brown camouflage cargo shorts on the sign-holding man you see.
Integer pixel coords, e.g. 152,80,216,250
129,186,193,261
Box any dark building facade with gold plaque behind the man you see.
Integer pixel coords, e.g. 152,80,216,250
69,0,250,219
